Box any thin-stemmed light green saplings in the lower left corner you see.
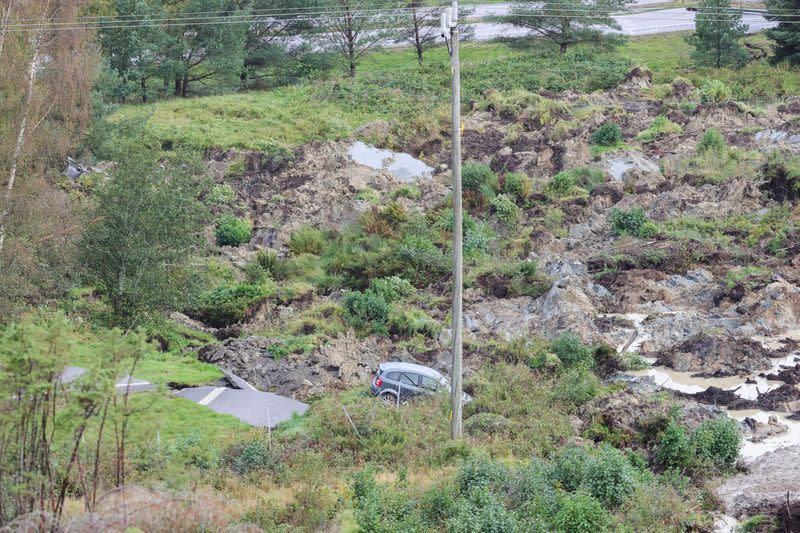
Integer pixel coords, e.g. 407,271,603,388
0,315,147,531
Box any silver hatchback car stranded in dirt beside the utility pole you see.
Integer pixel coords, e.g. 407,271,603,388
370,362,472,404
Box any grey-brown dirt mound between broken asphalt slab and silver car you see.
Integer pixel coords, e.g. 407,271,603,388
197,332,396,398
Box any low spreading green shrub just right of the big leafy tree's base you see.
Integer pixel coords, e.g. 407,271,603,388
193,282,275,328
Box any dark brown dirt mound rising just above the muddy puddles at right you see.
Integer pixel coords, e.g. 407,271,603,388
657,333,771,377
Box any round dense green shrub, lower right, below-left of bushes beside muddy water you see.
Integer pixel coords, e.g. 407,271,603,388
583,444,636,507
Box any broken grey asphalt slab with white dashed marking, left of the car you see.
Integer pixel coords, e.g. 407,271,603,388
178,384,308,428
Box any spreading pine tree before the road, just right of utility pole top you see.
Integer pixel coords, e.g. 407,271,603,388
498,0,629,54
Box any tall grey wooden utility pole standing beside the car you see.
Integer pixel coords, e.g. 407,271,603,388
441,0,464,439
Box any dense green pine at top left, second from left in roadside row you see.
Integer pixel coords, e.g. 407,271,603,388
167,0,249,96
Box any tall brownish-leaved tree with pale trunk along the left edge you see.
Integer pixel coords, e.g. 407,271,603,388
0,0,98,321
